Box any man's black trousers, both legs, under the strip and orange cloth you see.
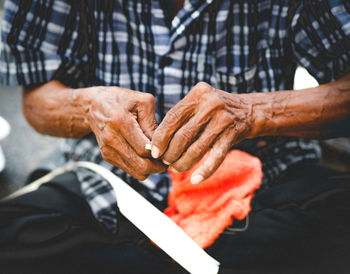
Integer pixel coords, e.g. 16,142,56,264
0,164,350,273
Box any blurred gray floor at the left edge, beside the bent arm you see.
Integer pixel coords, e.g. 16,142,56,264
0,86,60,197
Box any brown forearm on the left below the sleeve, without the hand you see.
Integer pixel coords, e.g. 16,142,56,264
23,81,91,138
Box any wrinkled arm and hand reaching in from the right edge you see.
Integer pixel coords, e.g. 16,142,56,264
152,74,350,184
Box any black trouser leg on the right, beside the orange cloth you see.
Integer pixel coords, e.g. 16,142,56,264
208,164,350,266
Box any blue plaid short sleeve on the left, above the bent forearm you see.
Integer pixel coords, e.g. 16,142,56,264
0,0,84,87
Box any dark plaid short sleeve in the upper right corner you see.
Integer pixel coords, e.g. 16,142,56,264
291,0,350,84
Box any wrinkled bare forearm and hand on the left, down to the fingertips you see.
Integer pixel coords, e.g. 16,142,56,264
23,80,166,180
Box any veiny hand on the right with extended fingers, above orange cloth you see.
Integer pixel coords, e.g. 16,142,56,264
152,83,252,184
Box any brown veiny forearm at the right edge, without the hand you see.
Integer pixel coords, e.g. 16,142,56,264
247,74,350,138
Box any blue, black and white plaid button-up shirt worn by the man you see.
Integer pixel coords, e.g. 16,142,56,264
0,0,350,230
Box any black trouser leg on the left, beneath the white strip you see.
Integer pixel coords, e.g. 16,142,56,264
0,173,185,273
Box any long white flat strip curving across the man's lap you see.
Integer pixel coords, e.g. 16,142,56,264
5,162,220,274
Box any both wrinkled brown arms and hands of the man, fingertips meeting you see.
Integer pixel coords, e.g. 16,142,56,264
23,74,350,183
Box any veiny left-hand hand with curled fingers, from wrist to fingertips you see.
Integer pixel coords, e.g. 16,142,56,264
85,87,166,180
